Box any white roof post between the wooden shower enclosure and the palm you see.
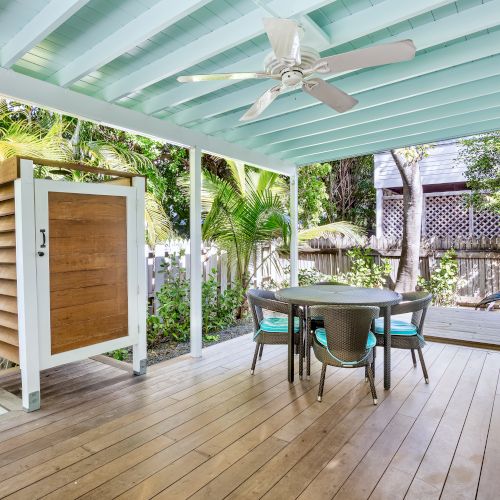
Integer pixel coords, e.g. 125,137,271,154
189,146,202,358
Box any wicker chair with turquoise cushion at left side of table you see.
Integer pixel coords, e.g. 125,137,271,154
247,289,304,378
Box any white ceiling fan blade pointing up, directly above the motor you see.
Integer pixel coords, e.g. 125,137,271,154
264,17,300,64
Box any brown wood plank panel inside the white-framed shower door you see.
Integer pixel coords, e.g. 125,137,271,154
49,192,128,354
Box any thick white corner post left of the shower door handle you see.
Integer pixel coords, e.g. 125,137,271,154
14,160,40,411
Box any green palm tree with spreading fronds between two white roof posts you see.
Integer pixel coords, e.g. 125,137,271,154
202,160,361,290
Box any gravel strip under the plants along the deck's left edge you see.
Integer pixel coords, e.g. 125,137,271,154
114,318,253,366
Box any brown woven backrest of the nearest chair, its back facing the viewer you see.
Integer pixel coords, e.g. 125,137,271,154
311,306,379,364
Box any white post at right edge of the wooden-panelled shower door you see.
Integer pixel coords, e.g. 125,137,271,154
132,177,148,375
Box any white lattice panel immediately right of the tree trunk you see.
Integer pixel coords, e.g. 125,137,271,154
425,195,469,238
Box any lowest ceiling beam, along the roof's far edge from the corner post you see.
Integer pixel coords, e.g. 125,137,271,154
296,117,500,166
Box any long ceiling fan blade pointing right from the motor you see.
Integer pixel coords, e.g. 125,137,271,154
316,40,416,74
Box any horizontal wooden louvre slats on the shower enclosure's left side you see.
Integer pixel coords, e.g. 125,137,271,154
0,158,19,363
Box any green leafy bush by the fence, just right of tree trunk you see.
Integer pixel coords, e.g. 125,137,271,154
418,249,460,307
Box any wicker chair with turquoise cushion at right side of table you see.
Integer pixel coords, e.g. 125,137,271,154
375,292,432,384
